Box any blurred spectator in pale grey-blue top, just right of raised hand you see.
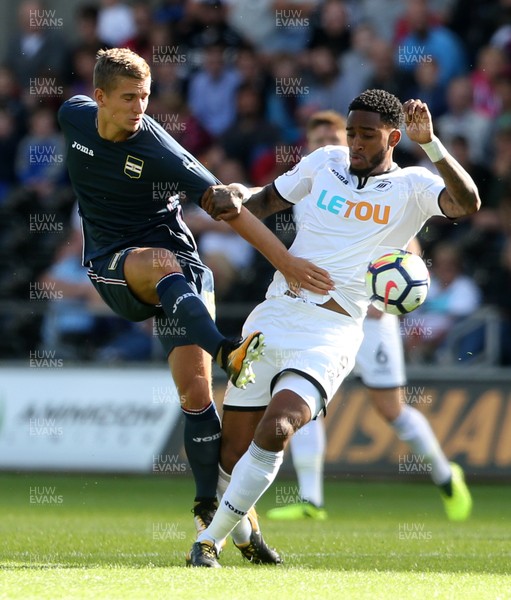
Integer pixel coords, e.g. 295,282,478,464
437,76,490,163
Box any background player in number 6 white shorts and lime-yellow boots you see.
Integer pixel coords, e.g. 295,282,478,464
267,111,472,521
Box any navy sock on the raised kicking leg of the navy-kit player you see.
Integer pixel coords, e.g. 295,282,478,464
156,273,225,359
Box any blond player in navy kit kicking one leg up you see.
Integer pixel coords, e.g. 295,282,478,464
58,48,330,552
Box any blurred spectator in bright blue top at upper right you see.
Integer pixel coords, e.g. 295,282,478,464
396,0,467,89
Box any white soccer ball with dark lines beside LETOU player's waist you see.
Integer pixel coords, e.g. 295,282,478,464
366,250,429,315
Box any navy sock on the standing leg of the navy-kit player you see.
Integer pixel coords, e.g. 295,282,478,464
182,402,222,500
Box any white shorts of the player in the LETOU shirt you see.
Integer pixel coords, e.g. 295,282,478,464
224,296,362,417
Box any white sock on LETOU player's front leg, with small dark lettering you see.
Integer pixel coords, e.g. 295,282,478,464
197,442,284,546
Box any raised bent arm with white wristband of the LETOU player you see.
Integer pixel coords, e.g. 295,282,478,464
403,100,481,218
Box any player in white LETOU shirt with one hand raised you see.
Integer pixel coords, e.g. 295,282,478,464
187,90,481,567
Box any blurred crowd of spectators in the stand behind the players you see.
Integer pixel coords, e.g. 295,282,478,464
0,0,511,365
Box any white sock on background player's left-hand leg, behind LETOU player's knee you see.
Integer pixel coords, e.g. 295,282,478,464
290,418,326,506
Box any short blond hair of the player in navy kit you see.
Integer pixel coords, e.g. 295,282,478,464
93,48,151,92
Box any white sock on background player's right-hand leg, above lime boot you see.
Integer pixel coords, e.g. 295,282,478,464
391,404,451,485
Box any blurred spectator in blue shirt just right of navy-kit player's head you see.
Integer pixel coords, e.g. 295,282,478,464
188,44,240,138
